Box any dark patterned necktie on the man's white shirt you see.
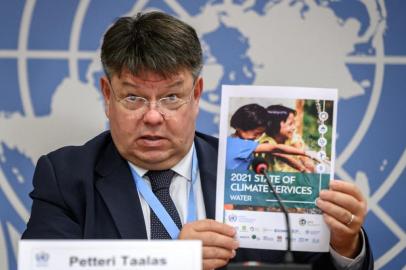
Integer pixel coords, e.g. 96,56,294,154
146,170,182,239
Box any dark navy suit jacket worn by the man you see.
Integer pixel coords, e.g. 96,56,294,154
22,131,372,269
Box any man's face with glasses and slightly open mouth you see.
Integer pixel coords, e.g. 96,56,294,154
101,69,203,170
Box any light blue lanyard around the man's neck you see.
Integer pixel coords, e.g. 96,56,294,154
130,146,198,239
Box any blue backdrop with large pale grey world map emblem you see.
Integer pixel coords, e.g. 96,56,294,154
0,0,406,270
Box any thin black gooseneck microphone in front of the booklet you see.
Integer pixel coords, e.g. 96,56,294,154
227,157,312,270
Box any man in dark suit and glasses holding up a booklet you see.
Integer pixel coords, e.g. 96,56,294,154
23,12,373,269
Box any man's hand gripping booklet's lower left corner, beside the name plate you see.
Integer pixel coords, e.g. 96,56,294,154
179,219,239,270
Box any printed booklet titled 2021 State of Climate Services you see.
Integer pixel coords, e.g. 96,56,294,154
216,85,338,252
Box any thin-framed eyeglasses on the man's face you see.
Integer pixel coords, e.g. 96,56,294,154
109,81,196,119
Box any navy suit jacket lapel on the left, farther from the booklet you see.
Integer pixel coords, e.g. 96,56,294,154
96,141,147,239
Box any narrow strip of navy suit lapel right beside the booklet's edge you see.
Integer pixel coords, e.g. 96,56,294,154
195,135,217,219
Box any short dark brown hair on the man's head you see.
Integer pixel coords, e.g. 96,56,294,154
101,11,203,79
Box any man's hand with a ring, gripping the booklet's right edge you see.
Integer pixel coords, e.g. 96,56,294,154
317,180,367,258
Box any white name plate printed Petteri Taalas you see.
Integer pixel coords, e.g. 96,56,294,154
18,240,202,270
